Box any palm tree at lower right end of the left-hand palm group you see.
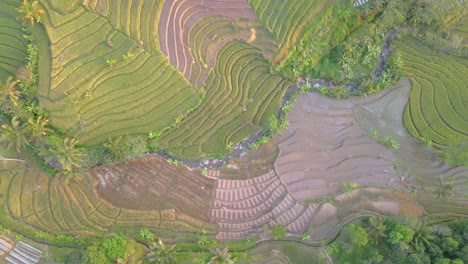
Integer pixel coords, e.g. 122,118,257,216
44,138,84,175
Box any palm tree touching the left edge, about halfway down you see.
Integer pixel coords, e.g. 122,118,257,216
0,116,28,153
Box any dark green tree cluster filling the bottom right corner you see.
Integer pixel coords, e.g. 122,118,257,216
324,217,468,264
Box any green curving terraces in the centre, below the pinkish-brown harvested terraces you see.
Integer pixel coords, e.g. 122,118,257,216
160,41,291,159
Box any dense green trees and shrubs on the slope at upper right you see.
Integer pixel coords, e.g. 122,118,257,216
279,0,466,95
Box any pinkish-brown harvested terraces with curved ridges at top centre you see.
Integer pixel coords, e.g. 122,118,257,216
158,0,276,87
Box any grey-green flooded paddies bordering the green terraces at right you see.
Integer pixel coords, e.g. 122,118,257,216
355,79,468,194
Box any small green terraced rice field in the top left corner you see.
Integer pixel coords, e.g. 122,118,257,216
0,0,27,81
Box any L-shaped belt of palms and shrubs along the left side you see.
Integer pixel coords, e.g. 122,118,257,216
0,0,152,177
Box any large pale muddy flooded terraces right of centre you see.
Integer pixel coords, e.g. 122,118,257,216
274,79,468,201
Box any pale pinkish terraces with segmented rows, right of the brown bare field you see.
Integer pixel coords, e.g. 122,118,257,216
211,171,318,239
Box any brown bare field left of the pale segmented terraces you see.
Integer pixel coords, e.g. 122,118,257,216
90,157,215,222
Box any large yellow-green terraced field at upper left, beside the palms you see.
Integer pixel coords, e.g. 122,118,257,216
39,0,200,145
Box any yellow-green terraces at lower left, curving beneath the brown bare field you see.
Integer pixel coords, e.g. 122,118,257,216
0,161,214,235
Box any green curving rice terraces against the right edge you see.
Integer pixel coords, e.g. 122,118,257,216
398,39,468,148
